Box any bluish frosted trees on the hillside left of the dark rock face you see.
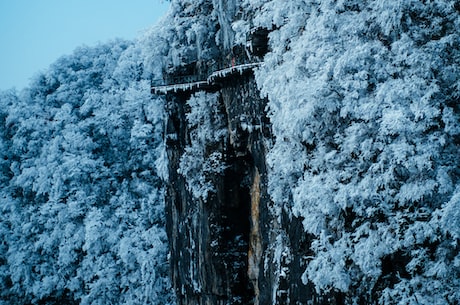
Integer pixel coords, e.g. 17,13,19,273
0,34,173,304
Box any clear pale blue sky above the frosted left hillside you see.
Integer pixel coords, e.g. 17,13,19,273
0,0,168,90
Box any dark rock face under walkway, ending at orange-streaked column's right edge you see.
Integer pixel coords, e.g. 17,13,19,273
167,69,270,304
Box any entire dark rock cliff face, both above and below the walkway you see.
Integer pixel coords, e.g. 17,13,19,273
163,5,341,305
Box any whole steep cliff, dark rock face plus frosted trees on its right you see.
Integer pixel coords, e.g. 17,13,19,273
159,0,460,304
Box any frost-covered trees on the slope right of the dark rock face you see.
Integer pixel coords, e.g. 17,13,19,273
253,0,460,304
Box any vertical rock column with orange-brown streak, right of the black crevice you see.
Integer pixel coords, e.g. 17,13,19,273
221,72,271,305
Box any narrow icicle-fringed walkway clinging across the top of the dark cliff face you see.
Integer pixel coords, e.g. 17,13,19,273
151,62,262,95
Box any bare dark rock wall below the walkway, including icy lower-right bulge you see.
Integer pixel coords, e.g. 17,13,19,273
166,72,332,304
